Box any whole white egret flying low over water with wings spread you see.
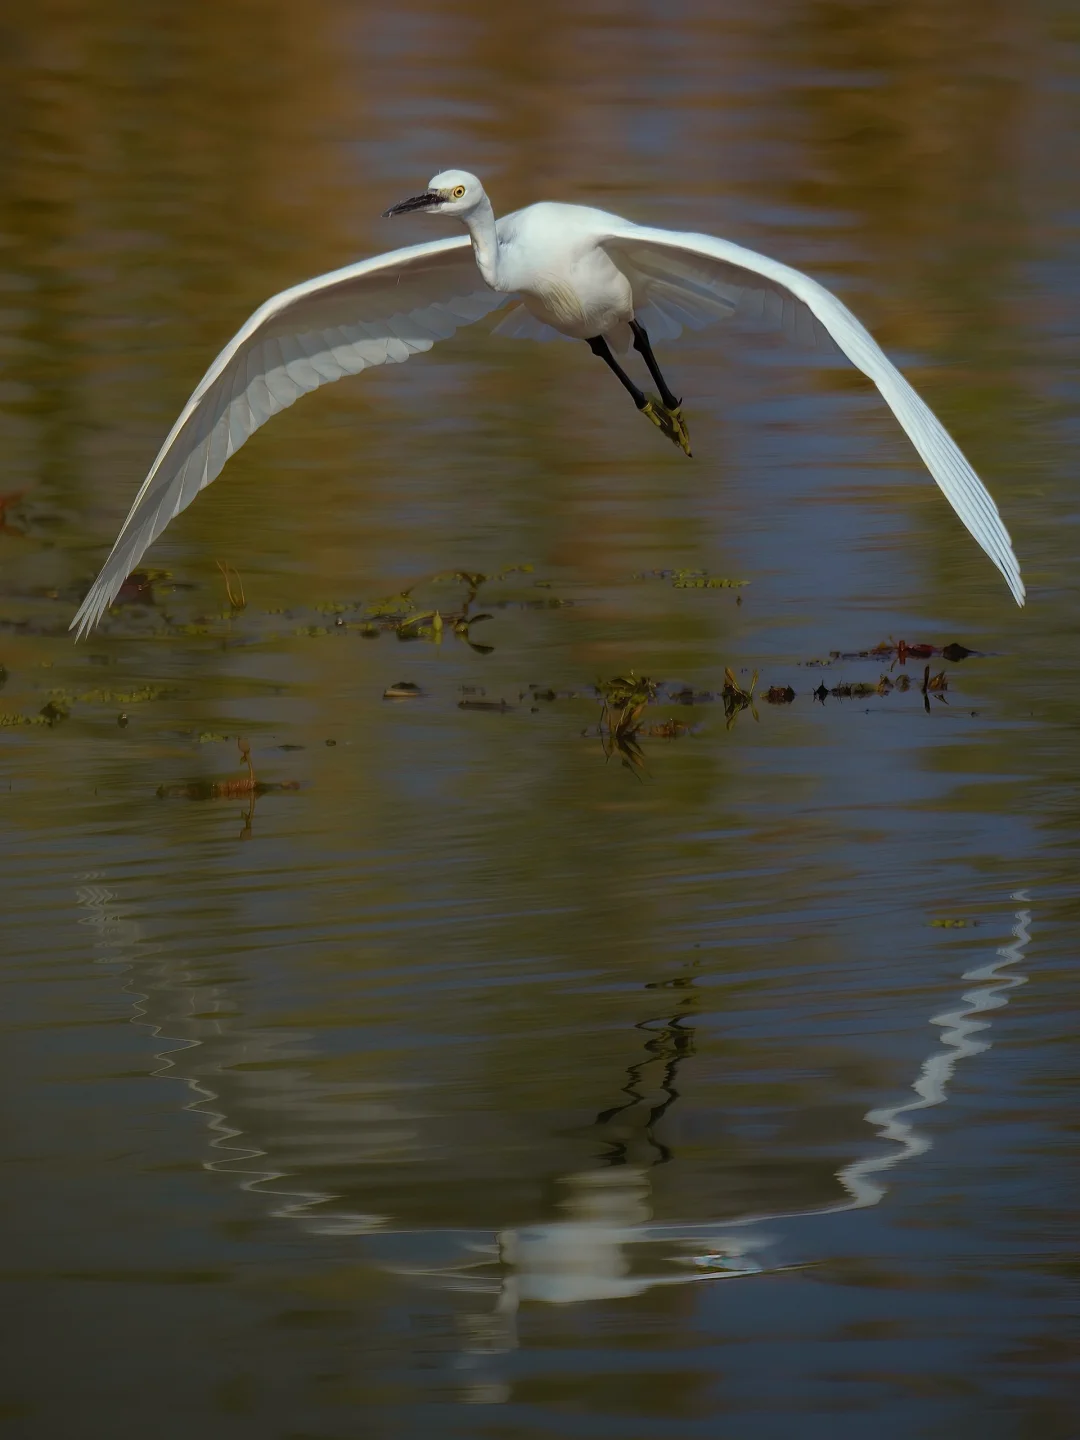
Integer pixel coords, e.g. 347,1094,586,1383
72,170,1024,635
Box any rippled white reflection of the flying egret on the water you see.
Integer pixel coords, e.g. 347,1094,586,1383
76,874,1031,1319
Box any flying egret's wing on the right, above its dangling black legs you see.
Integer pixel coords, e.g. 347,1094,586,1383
598,222,1024,605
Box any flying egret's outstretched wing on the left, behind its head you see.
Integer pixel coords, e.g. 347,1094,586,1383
71,235,507,636
